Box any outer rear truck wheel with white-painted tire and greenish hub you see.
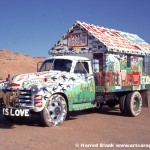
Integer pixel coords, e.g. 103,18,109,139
126,91,142,117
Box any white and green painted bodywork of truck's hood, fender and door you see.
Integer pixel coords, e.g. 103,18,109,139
0,57,95,111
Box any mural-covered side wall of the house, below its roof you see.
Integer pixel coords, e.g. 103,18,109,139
92,53,150,92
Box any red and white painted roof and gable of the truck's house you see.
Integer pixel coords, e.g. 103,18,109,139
49,21,150,55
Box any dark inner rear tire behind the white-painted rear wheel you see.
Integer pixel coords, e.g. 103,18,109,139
119,95,127,116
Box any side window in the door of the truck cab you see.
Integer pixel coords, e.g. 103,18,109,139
74,62,89,74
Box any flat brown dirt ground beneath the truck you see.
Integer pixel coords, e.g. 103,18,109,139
0,106,150,150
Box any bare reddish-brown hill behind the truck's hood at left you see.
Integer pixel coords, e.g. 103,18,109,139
0,50,45,80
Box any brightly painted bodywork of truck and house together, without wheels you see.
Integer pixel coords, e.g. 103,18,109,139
1,21,150,112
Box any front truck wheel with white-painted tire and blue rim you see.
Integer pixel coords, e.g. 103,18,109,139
41,94,67,127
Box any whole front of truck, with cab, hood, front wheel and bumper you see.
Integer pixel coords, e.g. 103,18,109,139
3,56,95,126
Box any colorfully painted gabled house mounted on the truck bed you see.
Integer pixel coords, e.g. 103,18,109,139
49,21,150,105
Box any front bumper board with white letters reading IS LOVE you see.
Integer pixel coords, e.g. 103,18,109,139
3,108,30,117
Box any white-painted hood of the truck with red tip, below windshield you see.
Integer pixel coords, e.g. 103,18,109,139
9,71,61,89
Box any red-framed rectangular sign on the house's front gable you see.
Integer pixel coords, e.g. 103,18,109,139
68,32,88,47
